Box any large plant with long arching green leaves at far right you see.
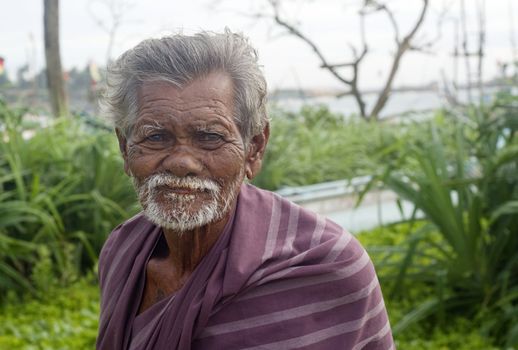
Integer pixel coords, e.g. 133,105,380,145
366,93,518,347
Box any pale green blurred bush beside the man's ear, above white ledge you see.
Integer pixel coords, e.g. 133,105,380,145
254,106,395,190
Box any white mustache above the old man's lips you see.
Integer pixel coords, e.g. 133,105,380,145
139,173,220,193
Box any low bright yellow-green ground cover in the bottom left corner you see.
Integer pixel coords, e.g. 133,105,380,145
0,276,99,350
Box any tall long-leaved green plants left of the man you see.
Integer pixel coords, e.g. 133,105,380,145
0,102,137,296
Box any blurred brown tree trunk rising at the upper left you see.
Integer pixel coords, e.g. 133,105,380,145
43,0,68,117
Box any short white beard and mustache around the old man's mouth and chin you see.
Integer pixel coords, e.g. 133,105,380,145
133,172,242,233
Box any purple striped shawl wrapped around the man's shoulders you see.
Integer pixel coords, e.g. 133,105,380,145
97,185,394,350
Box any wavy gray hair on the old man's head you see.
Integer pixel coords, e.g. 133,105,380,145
103,29,268,143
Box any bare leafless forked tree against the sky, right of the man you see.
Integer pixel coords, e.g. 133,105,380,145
260,0,431,119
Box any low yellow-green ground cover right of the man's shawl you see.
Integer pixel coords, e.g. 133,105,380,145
358,221,498,350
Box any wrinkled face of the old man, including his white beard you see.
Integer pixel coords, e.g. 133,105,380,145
119,72,251,232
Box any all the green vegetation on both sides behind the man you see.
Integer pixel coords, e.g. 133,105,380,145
0,89,518,349
